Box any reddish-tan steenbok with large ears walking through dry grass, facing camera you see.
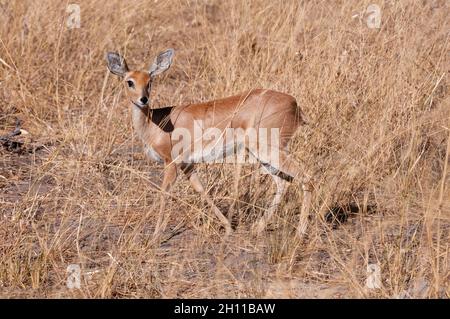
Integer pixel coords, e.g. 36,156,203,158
107,49,312,236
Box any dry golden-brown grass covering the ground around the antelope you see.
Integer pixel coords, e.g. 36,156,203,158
0,0,450,298
